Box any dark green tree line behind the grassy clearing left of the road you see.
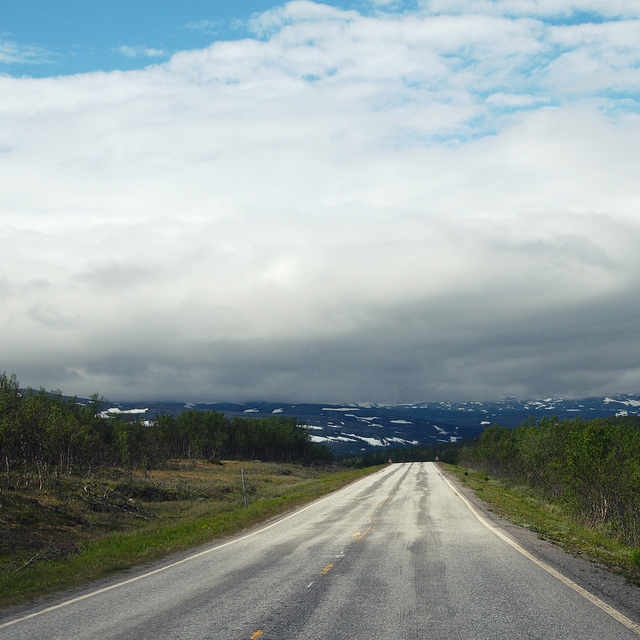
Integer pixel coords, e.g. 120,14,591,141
0,373,332,487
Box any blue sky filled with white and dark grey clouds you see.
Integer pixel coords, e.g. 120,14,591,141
0,0,640,403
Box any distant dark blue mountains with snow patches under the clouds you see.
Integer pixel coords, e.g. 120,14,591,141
91,394,640,455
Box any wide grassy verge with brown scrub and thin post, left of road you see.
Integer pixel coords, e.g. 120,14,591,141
0,461,379,607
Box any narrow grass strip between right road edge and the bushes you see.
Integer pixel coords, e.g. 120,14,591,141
442,465,640,585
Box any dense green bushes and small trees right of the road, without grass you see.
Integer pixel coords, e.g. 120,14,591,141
459,417,640,545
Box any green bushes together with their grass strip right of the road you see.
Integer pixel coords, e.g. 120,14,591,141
450,417,640,584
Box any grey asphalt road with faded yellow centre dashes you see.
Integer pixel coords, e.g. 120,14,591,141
0,463,640,640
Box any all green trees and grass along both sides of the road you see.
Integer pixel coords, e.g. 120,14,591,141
0,374,640,606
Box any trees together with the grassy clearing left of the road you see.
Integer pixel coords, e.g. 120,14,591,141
0,374,375,606
